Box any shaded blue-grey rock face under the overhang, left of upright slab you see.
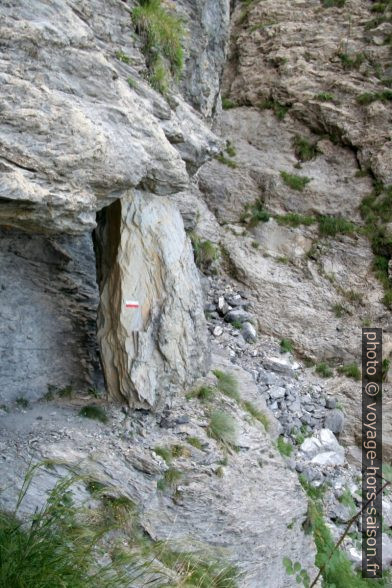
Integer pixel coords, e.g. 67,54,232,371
0,228,102,405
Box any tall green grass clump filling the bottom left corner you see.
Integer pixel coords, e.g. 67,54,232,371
0,466,143,588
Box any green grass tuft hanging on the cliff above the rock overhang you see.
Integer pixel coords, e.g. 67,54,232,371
132,0,184,95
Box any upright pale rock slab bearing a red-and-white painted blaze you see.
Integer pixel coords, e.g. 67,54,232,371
95,192,209,408
